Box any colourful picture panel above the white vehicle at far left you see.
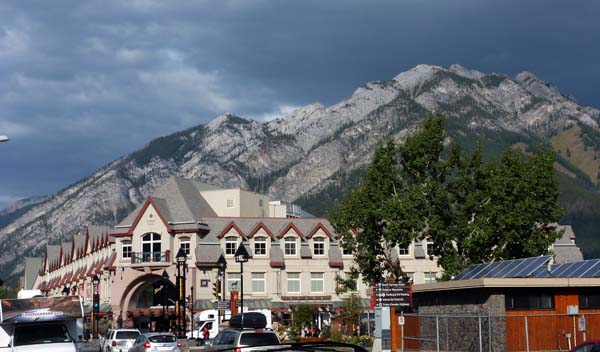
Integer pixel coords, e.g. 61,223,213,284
0,296,83,323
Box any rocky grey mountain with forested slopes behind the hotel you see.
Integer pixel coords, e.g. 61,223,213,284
0,65,600,282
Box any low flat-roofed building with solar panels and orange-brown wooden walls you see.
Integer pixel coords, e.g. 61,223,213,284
404,256,600,351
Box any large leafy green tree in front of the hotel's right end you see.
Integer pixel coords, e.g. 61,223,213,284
330,114,562,283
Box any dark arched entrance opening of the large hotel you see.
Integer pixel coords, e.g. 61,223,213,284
122,275,177,331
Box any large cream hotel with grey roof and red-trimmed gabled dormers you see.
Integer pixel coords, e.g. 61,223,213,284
22,177,440,325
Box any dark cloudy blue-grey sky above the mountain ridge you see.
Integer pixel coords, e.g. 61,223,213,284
0,0,600,209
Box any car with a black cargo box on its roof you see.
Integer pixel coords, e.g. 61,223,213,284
207,312,280,352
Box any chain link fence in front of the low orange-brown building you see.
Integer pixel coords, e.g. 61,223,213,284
395,313,600,352
